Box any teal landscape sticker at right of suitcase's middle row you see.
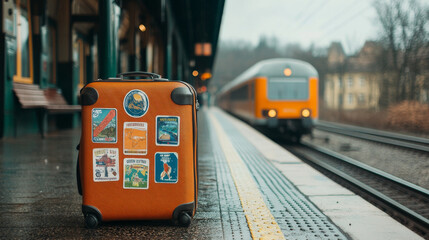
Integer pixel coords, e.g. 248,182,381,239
156,116,180,146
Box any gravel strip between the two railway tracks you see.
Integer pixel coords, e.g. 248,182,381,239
302,130,429,189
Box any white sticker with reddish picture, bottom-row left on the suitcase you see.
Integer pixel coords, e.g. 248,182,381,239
93,148,119,182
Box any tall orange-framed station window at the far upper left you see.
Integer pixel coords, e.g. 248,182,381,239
13,0,33,83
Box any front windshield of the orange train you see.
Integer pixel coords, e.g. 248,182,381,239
268,78,308,100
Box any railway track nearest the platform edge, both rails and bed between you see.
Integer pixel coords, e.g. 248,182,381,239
284,143,429,239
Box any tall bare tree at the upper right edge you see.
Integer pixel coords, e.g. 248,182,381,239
374,0,429,102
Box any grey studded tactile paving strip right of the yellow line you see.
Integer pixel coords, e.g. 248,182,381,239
213,112,347,239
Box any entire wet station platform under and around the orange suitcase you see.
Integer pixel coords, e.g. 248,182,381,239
0,108,420,239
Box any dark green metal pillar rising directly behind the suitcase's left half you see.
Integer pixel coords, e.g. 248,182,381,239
97,0,120,79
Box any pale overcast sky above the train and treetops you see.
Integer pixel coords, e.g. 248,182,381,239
220,0,381,53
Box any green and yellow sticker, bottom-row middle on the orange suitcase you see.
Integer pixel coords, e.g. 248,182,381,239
124,158,149,189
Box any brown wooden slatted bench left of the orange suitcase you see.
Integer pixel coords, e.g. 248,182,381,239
13,83,81,138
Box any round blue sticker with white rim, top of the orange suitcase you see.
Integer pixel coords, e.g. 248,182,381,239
124,89,149,118
